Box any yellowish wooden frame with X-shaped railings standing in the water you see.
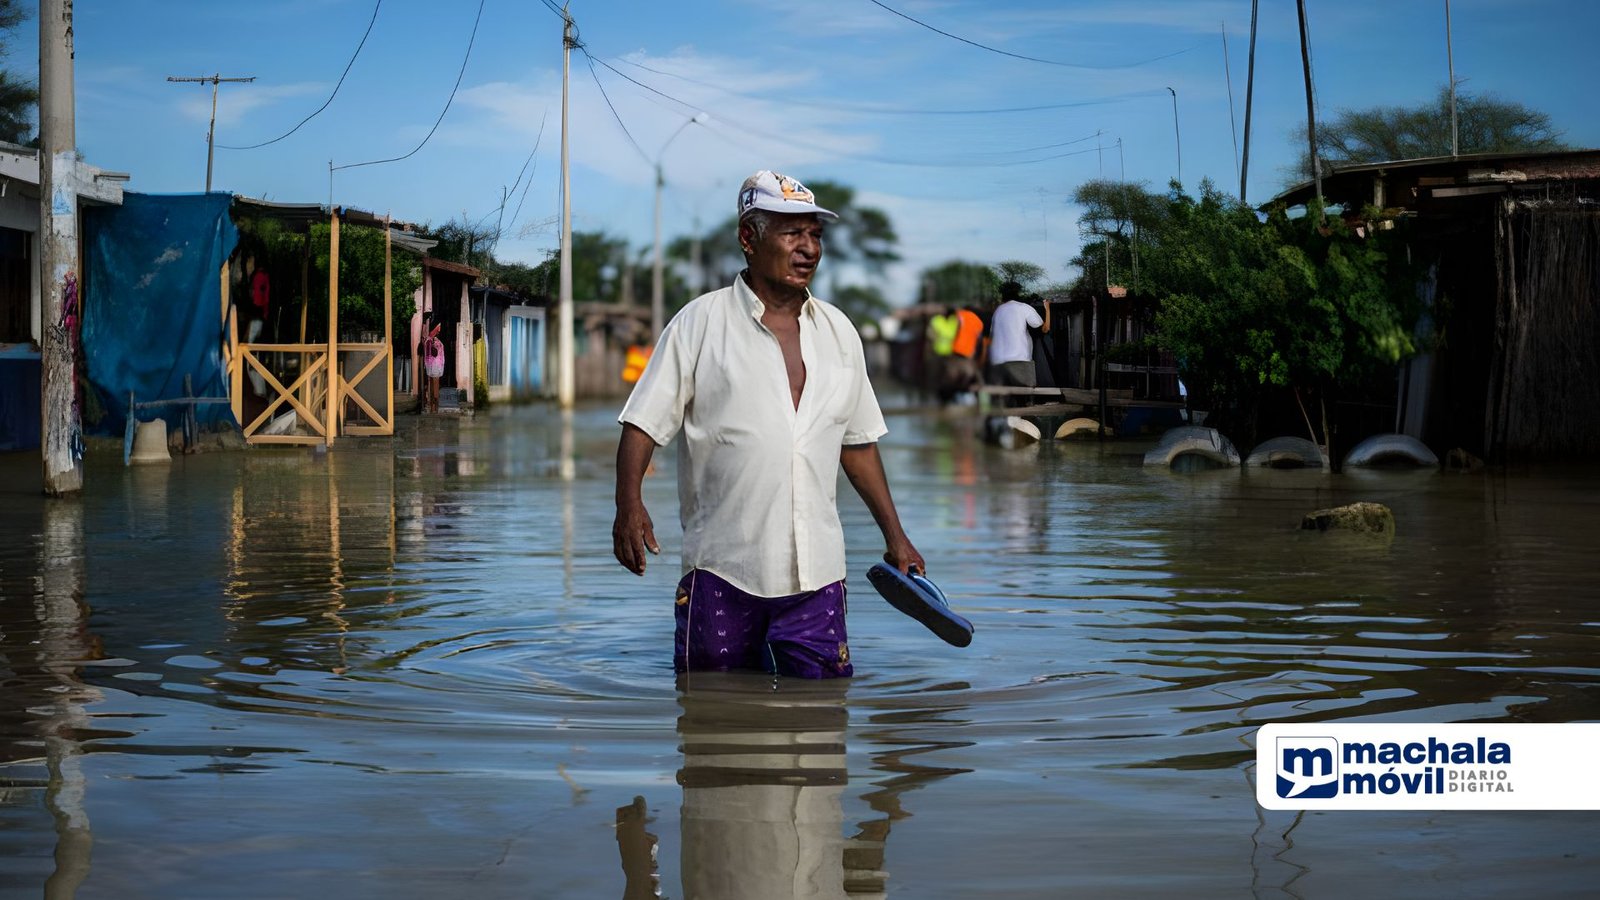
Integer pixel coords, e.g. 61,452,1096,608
221,207,406,447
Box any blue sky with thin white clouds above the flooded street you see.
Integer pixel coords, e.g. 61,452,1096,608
12,0,1600,304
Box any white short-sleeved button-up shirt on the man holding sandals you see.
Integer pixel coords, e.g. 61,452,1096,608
618,277,888,597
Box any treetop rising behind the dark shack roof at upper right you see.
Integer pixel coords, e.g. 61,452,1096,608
1296,88,1566,178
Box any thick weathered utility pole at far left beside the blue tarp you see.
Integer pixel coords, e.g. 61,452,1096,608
38,0,80,496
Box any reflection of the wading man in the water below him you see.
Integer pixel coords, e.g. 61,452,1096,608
616,673,966,900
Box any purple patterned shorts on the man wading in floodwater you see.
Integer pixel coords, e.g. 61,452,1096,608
672,569,854,677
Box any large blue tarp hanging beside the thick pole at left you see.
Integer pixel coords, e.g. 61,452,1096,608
83,192,238,434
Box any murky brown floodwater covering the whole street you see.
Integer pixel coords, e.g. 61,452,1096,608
0,400,1600,900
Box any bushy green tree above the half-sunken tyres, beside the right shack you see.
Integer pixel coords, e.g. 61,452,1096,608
1144,183,1421,432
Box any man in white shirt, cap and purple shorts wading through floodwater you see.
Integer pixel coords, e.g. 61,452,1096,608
611,171,923,677
